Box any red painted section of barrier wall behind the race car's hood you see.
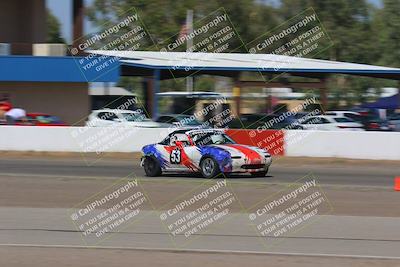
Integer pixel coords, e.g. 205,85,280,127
226,129,285,155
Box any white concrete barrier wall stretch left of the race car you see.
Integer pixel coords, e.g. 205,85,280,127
0,126,168,152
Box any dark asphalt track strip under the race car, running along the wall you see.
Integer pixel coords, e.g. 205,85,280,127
0,154,400,187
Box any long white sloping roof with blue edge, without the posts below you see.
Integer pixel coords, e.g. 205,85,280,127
88,50,400,80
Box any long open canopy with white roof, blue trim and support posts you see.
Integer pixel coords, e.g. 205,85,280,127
87,50,400,116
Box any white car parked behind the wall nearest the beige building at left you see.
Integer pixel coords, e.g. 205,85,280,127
86,109,165,128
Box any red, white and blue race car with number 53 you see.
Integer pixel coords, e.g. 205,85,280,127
141,129,272,178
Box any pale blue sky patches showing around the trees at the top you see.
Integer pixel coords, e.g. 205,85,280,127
46,0,382,43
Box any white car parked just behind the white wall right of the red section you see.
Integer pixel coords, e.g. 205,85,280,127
300,115,364,131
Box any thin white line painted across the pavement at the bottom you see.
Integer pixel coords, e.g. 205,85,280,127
0,244,400,260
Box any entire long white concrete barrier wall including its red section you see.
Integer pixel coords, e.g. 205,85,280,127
0,126,400,160
